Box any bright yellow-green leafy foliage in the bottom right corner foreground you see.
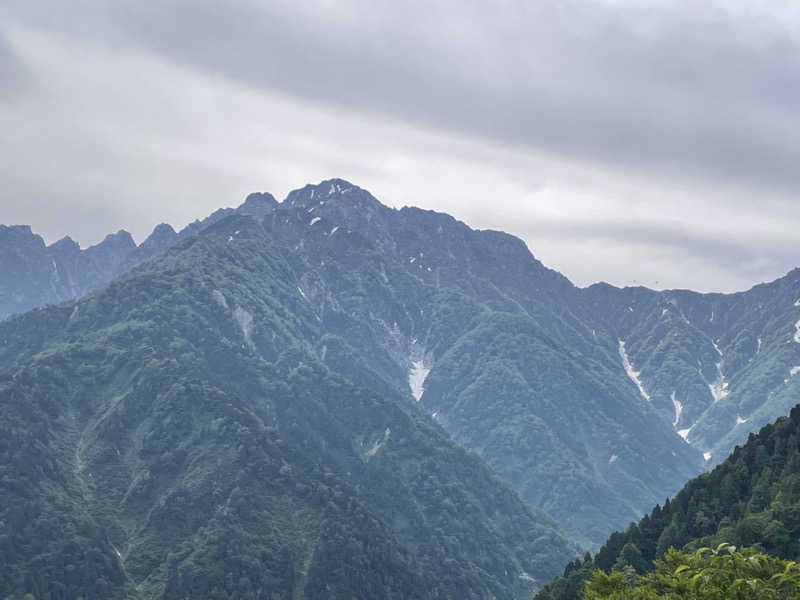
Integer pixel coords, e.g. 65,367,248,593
584,544,800,600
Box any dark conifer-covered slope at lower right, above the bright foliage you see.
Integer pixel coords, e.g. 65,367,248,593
536,406,800,600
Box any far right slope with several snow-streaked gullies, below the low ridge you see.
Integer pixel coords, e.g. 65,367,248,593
583,269,800,464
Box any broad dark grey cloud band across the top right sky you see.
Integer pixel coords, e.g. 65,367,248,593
7,0,800,194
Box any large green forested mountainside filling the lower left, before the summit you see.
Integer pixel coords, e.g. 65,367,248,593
0,215,575,599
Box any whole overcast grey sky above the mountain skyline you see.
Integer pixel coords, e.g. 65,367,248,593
0,0,800,291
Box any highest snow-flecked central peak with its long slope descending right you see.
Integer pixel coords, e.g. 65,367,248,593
264,180,702,544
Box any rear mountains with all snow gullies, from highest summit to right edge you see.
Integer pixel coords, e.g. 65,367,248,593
0,179,800,546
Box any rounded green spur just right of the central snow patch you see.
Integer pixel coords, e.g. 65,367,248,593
423,312,698,543
